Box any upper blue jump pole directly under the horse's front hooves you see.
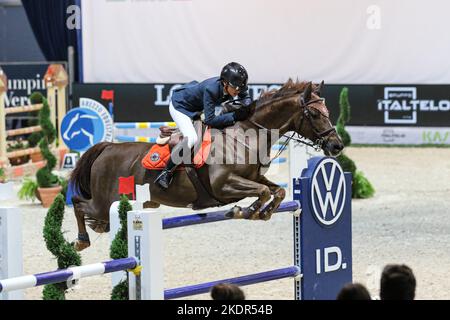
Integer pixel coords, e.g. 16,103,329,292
163,201,299,230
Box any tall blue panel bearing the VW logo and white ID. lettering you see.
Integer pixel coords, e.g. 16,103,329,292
294,157,352,300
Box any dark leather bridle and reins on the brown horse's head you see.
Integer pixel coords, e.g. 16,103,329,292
249,94,336,164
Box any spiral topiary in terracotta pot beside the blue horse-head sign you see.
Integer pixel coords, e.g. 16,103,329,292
30,93,63,208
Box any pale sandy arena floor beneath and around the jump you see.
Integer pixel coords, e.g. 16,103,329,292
1,147,450,300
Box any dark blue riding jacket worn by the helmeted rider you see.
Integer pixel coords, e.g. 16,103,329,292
172,77,252,129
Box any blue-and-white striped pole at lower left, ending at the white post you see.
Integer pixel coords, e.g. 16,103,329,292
0,257,138,293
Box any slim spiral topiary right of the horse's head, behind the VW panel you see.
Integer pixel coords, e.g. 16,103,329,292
336,88,375,199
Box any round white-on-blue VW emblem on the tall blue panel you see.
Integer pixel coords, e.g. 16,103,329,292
311,158,346,226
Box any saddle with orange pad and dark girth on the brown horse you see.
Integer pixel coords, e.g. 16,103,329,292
141,120,224,210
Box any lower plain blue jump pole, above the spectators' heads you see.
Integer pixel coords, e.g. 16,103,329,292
164,266,300,300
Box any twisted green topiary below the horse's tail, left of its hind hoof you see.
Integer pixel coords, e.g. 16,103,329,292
42,194,81,300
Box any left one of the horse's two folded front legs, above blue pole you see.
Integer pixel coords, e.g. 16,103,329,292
222,174,271,220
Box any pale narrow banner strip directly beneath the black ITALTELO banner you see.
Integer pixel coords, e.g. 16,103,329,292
346,126,450,145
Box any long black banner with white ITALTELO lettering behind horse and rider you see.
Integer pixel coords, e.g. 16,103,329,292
74,84,450,127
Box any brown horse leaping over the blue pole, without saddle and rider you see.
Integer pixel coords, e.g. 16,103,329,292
71,80,344,251
